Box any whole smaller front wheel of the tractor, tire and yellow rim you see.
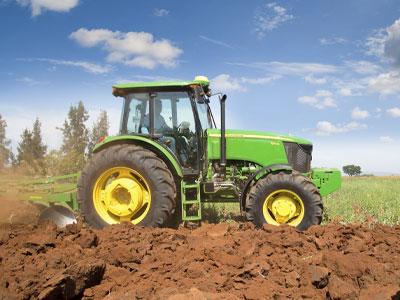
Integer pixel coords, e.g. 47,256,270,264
246,172,323,230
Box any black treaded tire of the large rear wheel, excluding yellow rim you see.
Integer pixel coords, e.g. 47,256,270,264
77,144,176,228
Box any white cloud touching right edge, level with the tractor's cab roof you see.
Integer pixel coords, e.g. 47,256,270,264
368,71,400,95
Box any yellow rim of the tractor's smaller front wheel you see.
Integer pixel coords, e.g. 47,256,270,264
263,190,304,226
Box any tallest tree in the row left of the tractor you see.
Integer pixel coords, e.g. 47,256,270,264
57,101,89,174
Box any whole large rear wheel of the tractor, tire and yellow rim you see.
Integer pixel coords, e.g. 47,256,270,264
77,144,176,228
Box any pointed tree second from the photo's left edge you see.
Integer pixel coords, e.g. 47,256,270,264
17,118,47,175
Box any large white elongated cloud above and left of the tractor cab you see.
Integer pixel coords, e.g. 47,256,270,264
69,28,183,69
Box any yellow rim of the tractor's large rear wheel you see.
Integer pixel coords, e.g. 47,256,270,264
93,167,151,224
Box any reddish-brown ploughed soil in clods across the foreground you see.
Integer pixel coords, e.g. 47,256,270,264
0,200,400,300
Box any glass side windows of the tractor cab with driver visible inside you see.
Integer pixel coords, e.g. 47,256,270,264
121,91,207,170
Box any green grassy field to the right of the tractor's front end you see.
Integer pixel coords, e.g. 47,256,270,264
324,177,400,225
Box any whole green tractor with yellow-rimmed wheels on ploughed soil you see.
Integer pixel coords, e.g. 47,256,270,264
76,76,341,230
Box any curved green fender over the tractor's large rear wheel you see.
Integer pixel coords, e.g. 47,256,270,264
93,135,183,178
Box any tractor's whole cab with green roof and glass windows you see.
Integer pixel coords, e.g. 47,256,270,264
113,77,213,173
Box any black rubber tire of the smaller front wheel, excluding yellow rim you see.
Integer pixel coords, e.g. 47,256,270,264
246,172,323,230
